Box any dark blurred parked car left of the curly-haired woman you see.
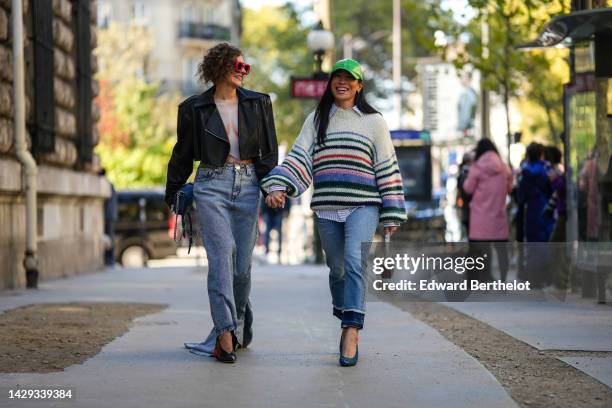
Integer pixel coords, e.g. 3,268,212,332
115,190,176,267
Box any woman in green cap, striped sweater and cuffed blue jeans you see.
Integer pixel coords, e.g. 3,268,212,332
262,59,406,366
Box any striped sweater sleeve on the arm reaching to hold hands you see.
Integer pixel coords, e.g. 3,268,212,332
261,113,316,197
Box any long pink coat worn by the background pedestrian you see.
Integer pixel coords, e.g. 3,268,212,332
463,151,512,241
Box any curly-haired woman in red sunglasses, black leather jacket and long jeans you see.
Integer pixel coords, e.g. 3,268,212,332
166,43,278,363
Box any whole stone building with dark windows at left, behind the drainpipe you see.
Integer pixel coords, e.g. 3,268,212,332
0,0,110,289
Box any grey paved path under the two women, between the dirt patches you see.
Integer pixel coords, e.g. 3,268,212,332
0,266,516,407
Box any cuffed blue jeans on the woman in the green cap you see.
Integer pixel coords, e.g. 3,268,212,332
316,206,379,329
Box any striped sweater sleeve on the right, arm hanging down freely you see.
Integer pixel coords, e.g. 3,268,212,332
374,115,406,225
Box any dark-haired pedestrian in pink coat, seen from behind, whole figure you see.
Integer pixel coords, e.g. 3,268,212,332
463,138,512,282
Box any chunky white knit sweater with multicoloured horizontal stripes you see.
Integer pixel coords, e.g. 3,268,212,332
262,108,406,223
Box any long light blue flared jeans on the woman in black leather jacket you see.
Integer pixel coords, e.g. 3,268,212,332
188,161,260,352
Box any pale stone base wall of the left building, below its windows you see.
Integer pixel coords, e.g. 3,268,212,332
0,159,110,289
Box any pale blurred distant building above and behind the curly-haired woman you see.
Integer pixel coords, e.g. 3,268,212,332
97,0,242,95
